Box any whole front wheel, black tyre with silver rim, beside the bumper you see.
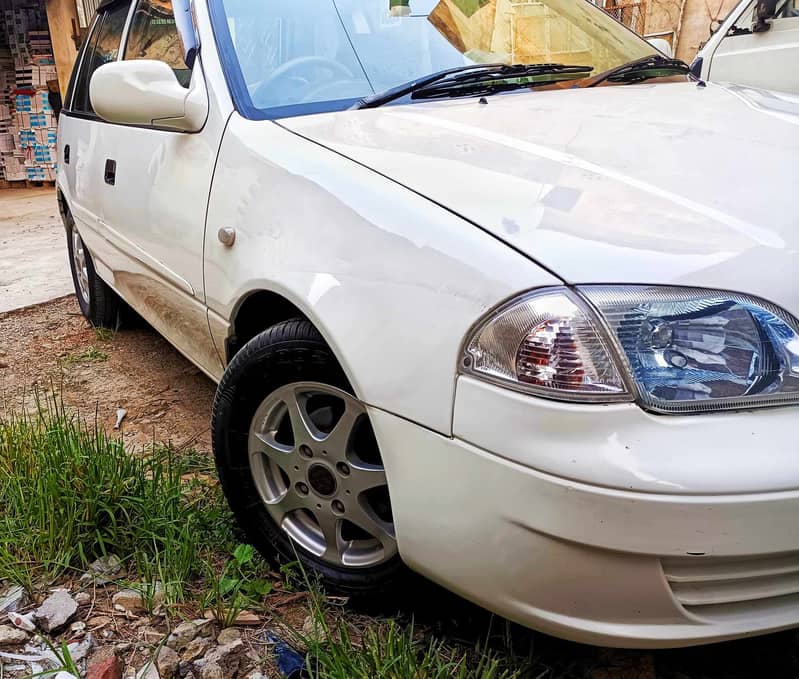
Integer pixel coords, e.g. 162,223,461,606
212,320,407,596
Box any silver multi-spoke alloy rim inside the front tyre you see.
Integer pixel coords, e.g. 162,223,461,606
248,382,397,568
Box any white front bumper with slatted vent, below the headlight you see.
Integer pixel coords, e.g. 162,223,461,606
371,378,799,648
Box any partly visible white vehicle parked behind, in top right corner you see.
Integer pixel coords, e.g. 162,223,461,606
691,0,799,94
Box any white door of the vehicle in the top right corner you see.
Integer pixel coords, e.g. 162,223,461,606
709,0,799,94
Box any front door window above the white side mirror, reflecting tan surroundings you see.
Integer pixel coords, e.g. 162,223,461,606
125,0,191,87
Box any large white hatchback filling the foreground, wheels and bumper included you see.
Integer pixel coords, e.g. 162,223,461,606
58,0,799,647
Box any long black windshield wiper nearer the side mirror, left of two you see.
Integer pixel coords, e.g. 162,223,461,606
352,64,593,109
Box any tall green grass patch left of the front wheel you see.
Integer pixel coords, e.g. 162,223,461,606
0,399,227,600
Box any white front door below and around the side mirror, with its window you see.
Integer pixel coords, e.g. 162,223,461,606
95,0,226,378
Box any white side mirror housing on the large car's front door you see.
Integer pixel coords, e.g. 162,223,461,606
89,59,208,132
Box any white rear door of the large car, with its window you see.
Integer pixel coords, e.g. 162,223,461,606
58,0,130,270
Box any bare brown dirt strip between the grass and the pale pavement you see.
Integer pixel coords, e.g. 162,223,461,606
0,295,214,452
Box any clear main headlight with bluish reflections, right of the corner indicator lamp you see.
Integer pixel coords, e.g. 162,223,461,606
580,286,799,413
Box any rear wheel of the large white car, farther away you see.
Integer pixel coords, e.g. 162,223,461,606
65,212,122,330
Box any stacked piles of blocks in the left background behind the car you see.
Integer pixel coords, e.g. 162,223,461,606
0,0,57,182
